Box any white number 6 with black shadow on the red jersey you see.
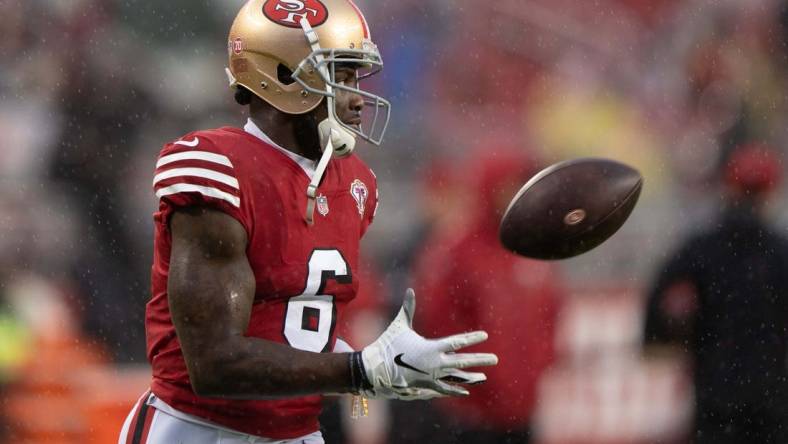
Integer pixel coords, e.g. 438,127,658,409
284,249,352,352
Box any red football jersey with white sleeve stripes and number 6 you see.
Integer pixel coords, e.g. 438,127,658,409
145,120,377,439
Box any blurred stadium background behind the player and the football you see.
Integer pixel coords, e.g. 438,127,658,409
0,0,788,444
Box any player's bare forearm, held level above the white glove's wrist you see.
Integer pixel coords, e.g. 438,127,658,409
189,337,351,399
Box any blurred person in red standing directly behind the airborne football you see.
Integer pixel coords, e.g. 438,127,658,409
415,149,559,443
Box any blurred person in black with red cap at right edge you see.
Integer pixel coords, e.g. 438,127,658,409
645,144,788,444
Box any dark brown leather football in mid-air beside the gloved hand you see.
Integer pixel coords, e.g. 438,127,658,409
499,158,643,259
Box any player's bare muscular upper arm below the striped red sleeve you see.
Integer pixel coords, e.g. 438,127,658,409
167,207,255,375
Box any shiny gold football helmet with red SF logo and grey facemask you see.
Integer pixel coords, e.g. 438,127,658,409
227,0,391,146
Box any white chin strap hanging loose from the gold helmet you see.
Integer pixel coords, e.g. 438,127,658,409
301,18,356,225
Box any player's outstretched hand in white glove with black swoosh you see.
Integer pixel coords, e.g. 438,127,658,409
361,289,498,399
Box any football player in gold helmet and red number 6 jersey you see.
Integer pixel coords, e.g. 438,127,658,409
119,0,497,444
